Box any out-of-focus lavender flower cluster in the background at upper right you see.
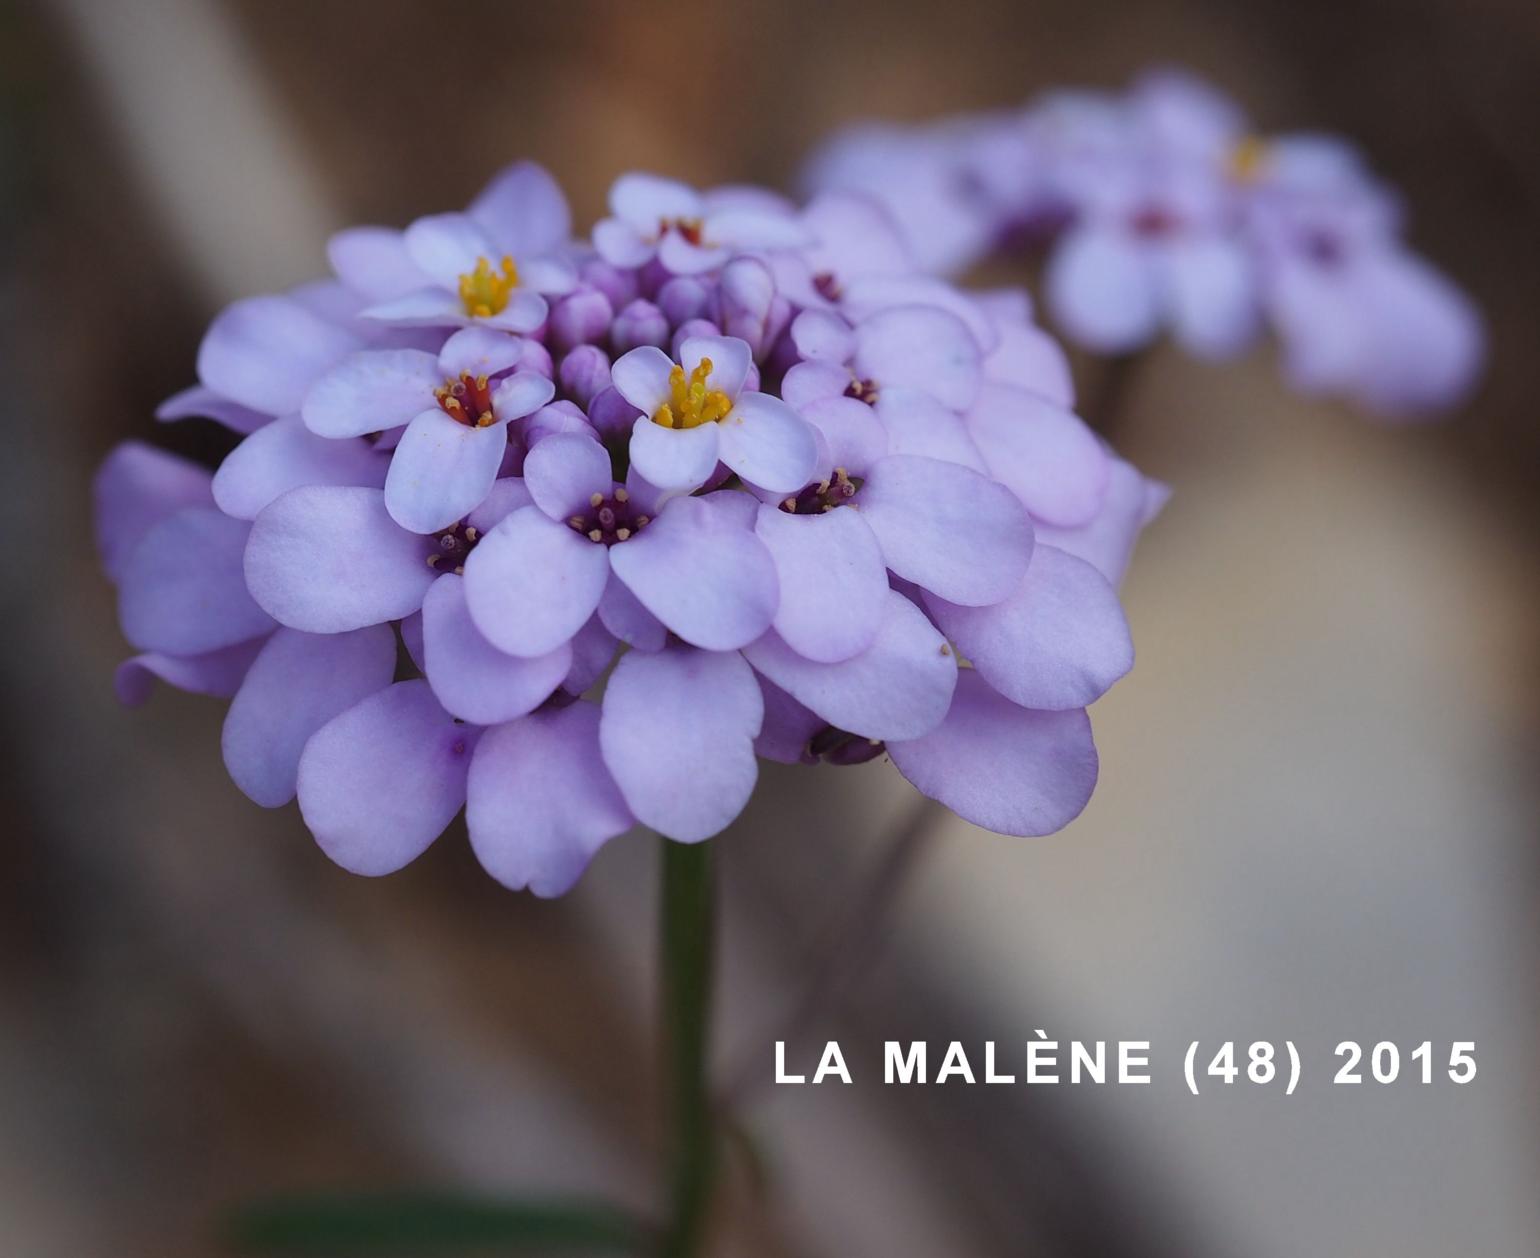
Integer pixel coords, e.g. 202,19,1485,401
804,71,1485,417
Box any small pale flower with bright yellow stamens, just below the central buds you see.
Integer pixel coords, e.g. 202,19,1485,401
610,336,816,493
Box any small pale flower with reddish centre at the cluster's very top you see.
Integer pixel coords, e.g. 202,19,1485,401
593,174,805,276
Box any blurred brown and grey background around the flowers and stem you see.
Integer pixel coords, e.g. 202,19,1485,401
0,0,1540,1258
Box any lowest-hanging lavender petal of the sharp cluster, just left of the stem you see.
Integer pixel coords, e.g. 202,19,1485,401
465,704,633,896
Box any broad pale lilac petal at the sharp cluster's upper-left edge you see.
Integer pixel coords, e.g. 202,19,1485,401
197,296,360,414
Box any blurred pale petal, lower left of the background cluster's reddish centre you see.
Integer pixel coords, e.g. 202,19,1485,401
1046,228,1160,354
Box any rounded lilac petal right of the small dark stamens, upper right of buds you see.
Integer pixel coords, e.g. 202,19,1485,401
853,306,983,411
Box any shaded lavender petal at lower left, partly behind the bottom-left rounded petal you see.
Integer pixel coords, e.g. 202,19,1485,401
220,625,396,808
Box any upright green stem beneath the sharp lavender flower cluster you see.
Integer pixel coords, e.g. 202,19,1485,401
659,839,719,1258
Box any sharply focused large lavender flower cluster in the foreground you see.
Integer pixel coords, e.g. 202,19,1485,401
97,163,1164,895
